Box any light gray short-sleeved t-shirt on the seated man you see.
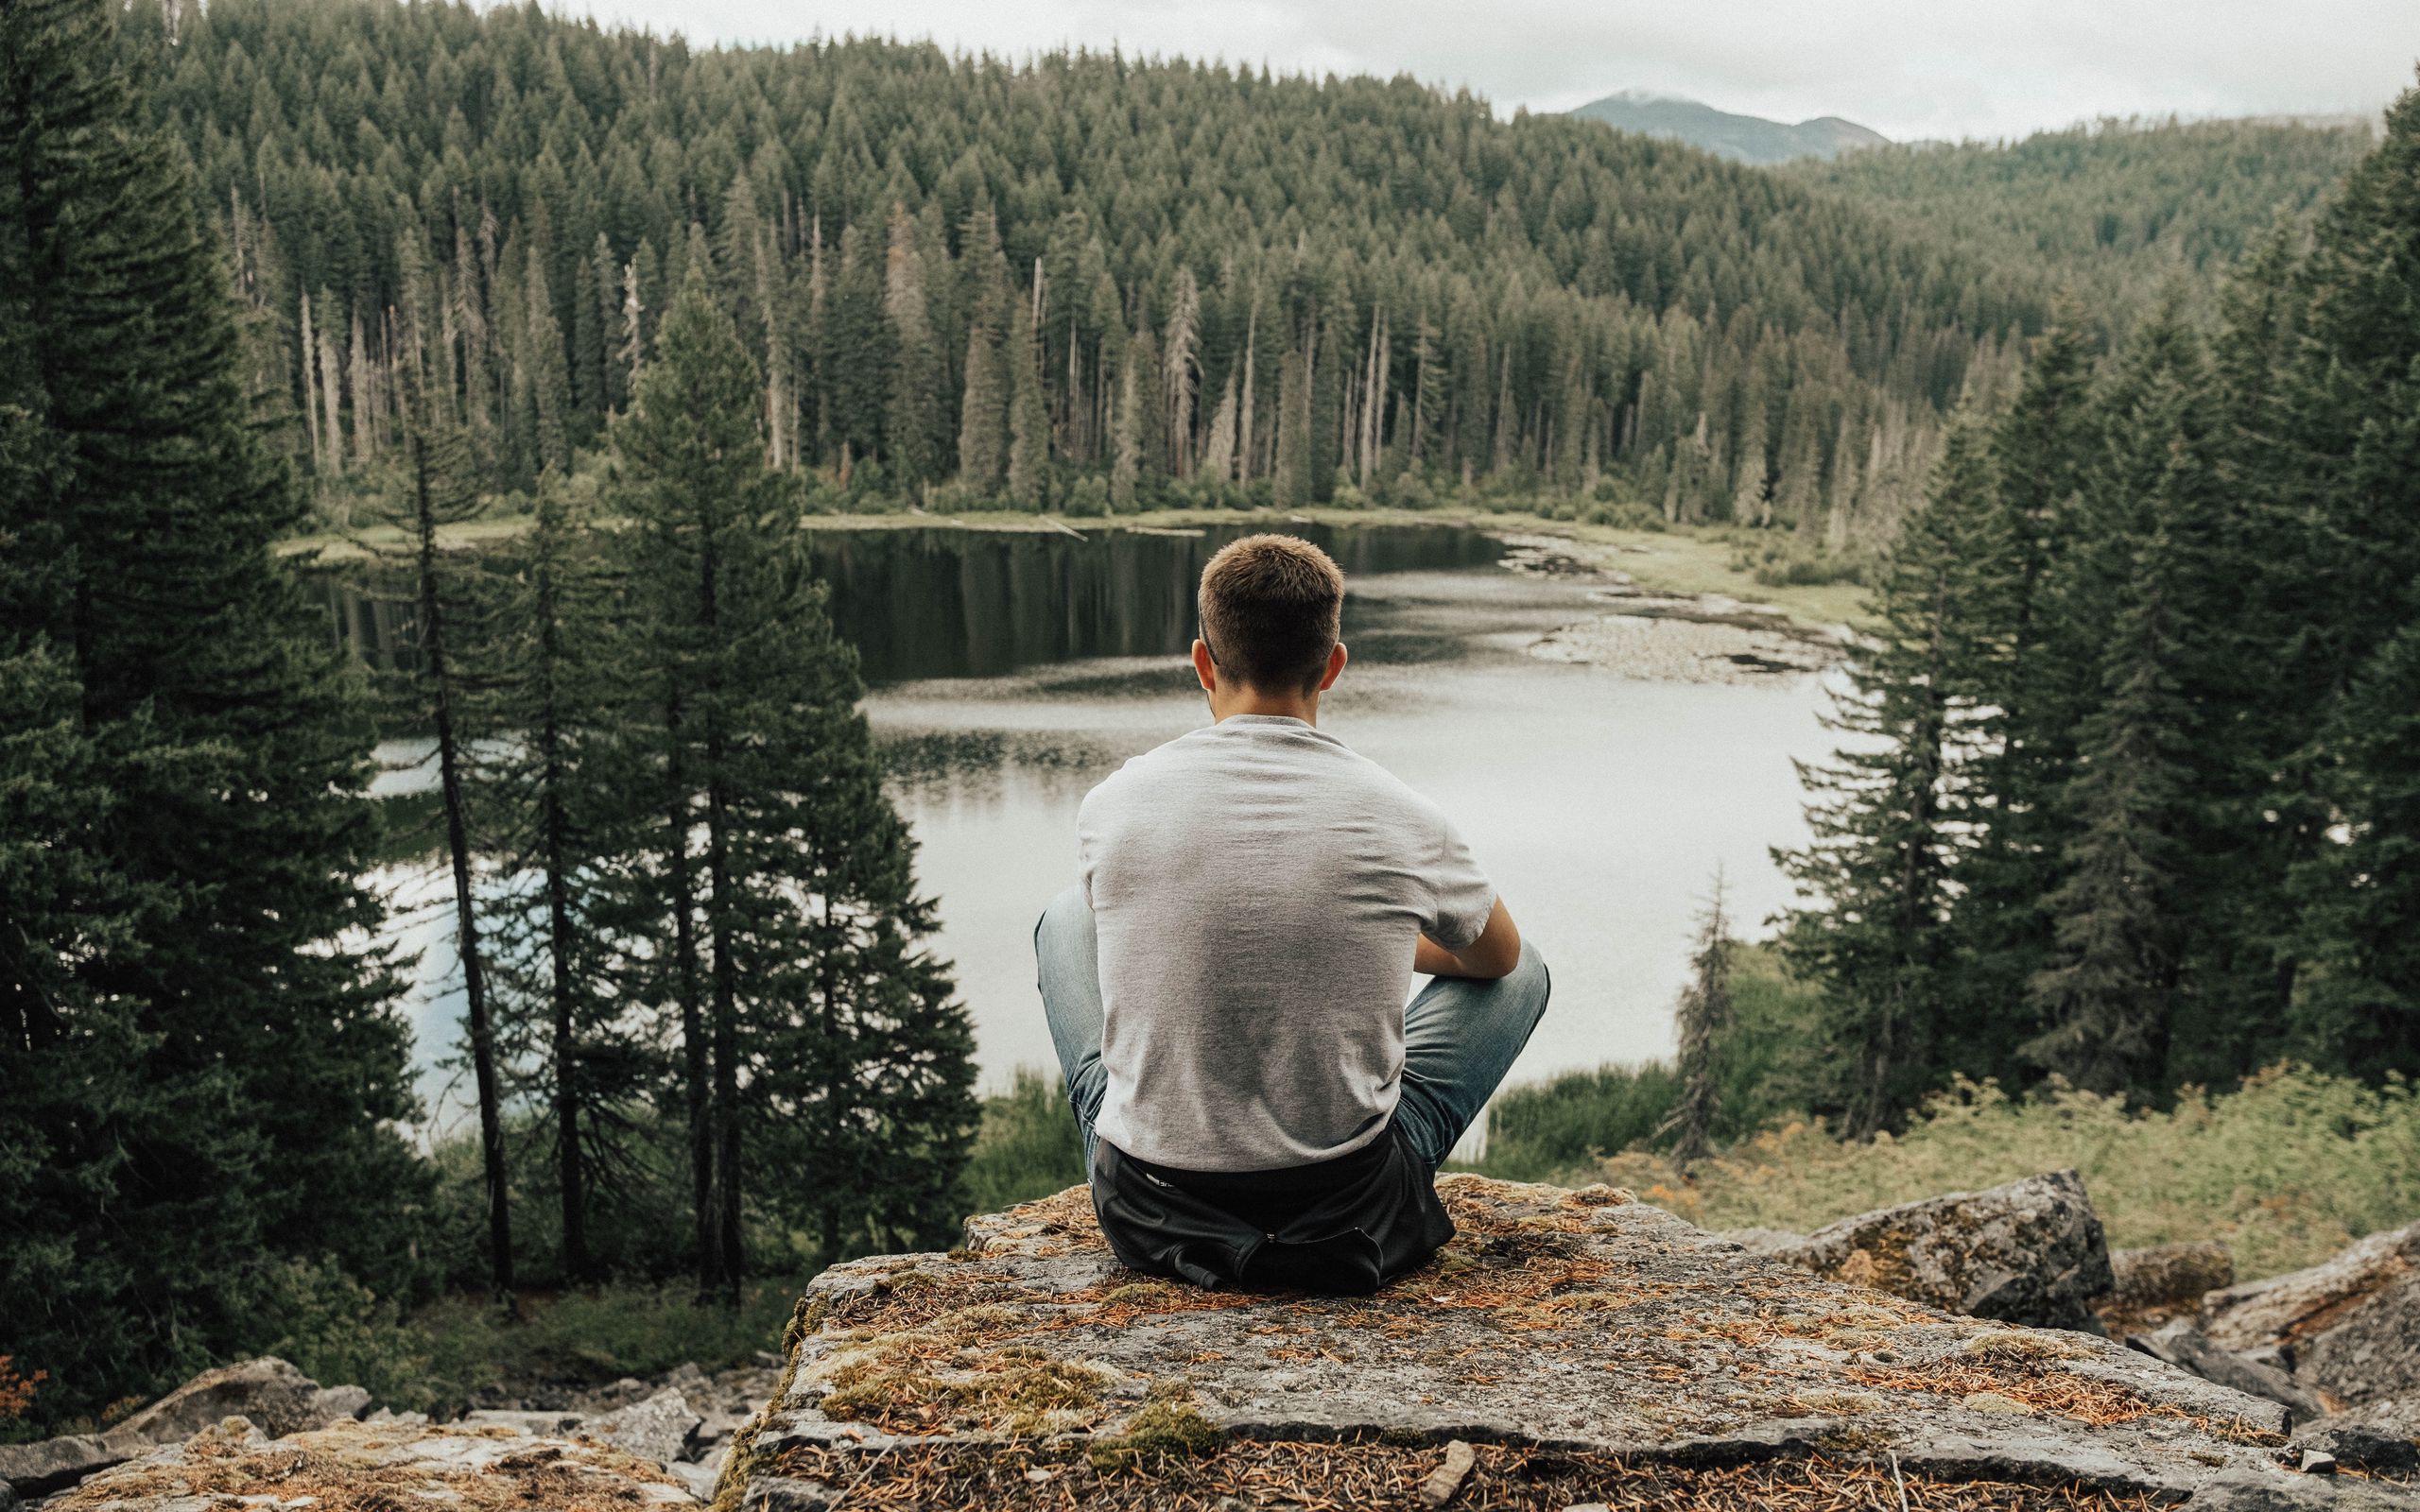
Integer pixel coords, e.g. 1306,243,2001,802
1077,713,1495,1171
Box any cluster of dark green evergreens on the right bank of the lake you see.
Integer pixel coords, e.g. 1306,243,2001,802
1784,79,2420,1130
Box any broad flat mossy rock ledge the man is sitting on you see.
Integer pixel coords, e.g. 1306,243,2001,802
717,1176,2420,1512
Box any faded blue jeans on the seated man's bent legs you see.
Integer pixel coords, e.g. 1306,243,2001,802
1033,888,1554,1171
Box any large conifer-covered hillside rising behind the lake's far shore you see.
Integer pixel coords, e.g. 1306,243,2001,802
113,0,2043,541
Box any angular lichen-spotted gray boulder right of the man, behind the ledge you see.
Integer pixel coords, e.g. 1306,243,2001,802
1772,1171,2113,1328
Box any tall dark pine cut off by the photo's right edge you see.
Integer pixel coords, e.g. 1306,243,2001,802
2265,90,2420,1072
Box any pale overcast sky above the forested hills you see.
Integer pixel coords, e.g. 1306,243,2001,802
571,0,2420,140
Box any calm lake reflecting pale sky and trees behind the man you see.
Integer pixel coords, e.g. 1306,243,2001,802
363,525,1832,1132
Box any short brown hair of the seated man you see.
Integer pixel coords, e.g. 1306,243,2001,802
1201,535,1345,692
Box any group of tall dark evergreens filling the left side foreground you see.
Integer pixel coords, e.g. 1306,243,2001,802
0,0,976,1433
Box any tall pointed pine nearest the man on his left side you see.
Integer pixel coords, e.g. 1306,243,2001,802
614,276,973,1299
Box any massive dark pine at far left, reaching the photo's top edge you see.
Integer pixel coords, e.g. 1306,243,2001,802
0,0,431,1413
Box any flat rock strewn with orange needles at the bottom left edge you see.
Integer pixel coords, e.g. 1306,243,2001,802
43,1420,692,1512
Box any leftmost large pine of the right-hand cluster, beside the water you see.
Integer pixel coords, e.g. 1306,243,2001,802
1776,426,2006,1135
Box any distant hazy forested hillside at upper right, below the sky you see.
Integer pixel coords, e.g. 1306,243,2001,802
1776,118,2377,336
